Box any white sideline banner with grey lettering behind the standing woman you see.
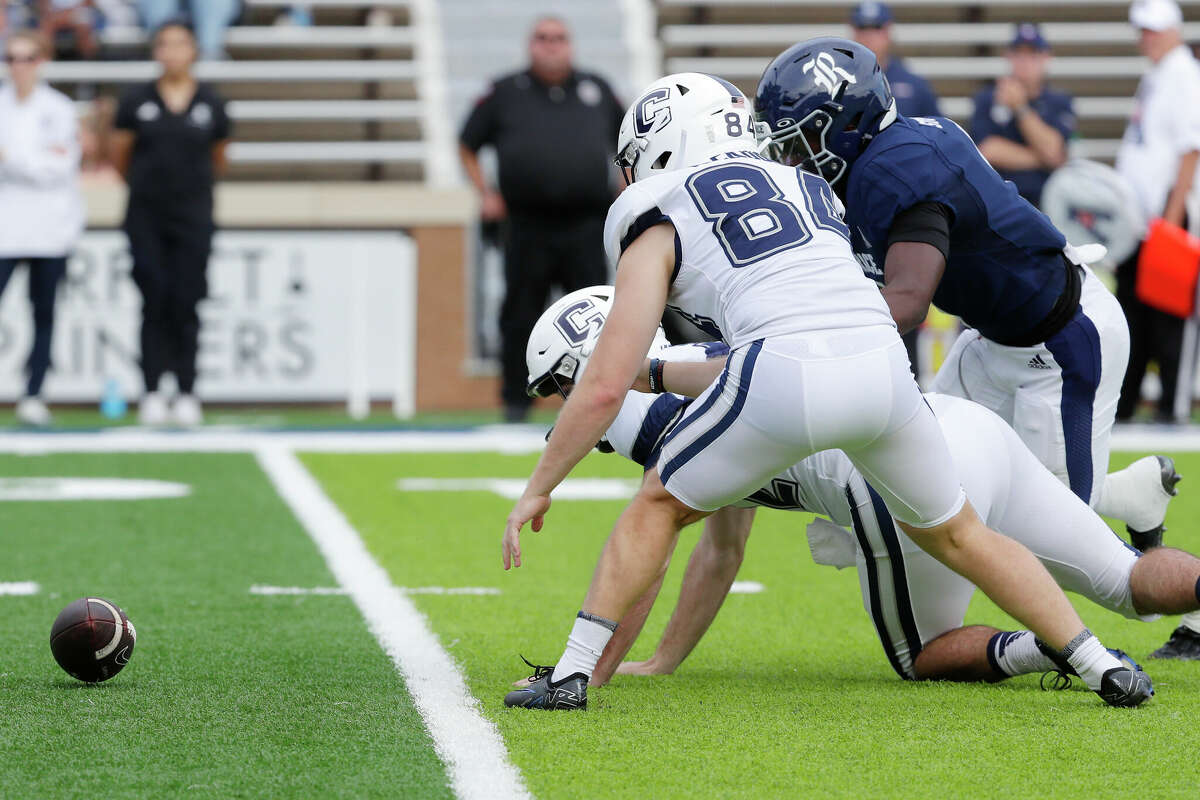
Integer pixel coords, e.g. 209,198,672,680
0,230,416,414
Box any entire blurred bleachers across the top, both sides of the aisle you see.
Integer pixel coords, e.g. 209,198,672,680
2,0,1200,176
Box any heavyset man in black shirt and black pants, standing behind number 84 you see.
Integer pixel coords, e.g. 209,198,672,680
458,17,624,422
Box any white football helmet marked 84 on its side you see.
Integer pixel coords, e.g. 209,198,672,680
616,72,758,184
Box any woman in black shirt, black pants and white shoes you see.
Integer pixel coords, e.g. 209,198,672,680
113,22,230,426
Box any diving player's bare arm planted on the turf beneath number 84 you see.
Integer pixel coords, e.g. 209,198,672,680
605,507,755,675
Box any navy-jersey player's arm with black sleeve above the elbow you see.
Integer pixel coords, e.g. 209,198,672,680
883,203,950,333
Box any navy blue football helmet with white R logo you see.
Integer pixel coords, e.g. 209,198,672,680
755,36,896,184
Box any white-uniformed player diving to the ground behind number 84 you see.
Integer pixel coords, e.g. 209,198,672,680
526,287,1200,686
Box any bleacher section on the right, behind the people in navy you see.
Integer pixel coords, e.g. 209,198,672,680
658,0,1200,161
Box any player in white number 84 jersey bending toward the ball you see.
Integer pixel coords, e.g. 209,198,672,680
502,73,1153,709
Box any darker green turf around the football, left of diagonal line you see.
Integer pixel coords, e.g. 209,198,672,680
0,455,450,799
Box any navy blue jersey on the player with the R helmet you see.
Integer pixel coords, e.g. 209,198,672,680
846,116,1067,341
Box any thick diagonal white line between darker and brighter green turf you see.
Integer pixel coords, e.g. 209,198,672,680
257,446,532,800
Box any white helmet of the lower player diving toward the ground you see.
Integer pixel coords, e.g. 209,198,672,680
526,285,670,397
